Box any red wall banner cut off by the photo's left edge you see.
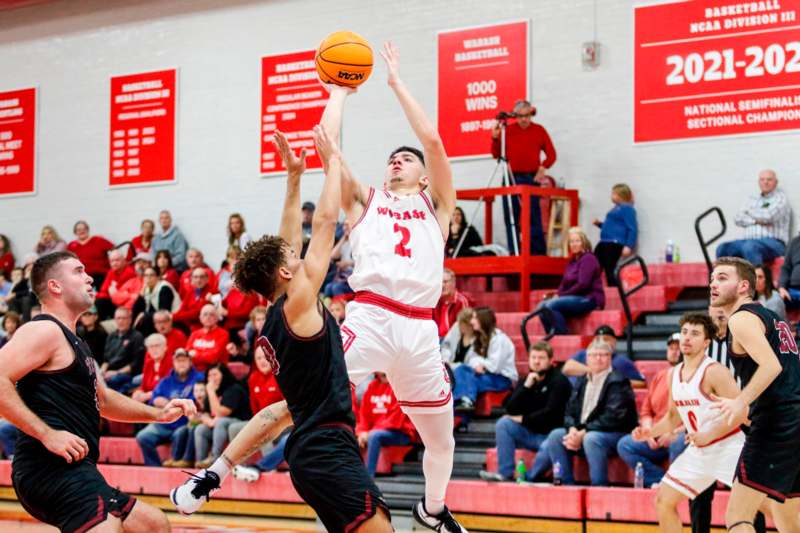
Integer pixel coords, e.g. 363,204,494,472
0,89,36,194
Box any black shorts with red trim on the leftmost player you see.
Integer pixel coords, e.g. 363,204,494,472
11,456,136,533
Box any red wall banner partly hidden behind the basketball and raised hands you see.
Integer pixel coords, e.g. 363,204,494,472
259,50,328,175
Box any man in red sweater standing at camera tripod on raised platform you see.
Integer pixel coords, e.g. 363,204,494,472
492,100,556,255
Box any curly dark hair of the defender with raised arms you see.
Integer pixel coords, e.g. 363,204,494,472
233,235,288,300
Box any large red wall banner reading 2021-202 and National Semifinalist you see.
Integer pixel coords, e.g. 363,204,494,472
634,0,800,142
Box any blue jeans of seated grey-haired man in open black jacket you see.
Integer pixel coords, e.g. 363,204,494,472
545,428,625,487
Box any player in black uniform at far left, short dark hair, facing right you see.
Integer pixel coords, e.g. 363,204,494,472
0,252,194,533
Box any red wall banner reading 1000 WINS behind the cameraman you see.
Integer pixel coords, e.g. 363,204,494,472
438,21,529,158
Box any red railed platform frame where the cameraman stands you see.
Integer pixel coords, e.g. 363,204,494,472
445,185,580,311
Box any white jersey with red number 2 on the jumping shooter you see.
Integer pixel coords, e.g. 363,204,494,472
348,187,444,308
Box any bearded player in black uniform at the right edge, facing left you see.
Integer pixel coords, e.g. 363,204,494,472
711,257,800,533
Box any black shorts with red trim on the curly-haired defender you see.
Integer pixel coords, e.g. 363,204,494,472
286,424,391,533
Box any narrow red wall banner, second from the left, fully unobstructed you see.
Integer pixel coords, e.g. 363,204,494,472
108,69,176,187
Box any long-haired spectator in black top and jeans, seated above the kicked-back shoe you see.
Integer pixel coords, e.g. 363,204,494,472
194,363,252,468
